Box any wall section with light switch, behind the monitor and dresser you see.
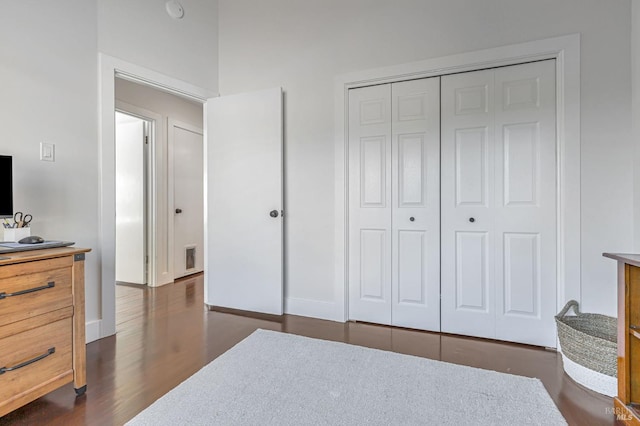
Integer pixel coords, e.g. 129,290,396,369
0,0,100,322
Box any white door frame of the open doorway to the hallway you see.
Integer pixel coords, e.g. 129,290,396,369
97,53,218,342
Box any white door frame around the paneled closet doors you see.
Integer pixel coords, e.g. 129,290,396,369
336,34,581,322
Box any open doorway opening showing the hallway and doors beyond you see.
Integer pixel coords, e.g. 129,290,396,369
115,78,204,328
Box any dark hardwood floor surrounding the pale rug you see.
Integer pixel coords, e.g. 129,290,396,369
0,275,615,426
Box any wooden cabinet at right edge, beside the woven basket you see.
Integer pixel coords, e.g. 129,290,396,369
603,253,640,425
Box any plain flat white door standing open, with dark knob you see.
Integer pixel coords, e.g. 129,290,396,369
205,88,283,315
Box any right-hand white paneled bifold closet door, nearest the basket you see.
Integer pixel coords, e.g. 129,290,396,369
441,61,557,347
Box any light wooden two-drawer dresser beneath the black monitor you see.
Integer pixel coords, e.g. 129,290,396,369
0,247,90,417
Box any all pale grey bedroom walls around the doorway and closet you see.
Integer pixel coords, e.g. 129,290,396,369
0,0,640,338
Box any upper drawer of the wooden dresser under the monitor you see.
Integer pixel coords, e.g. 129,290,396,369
0,256,73,324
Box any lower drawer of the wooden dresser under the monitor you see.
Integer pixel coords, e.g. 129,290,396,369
0,308,73,412
